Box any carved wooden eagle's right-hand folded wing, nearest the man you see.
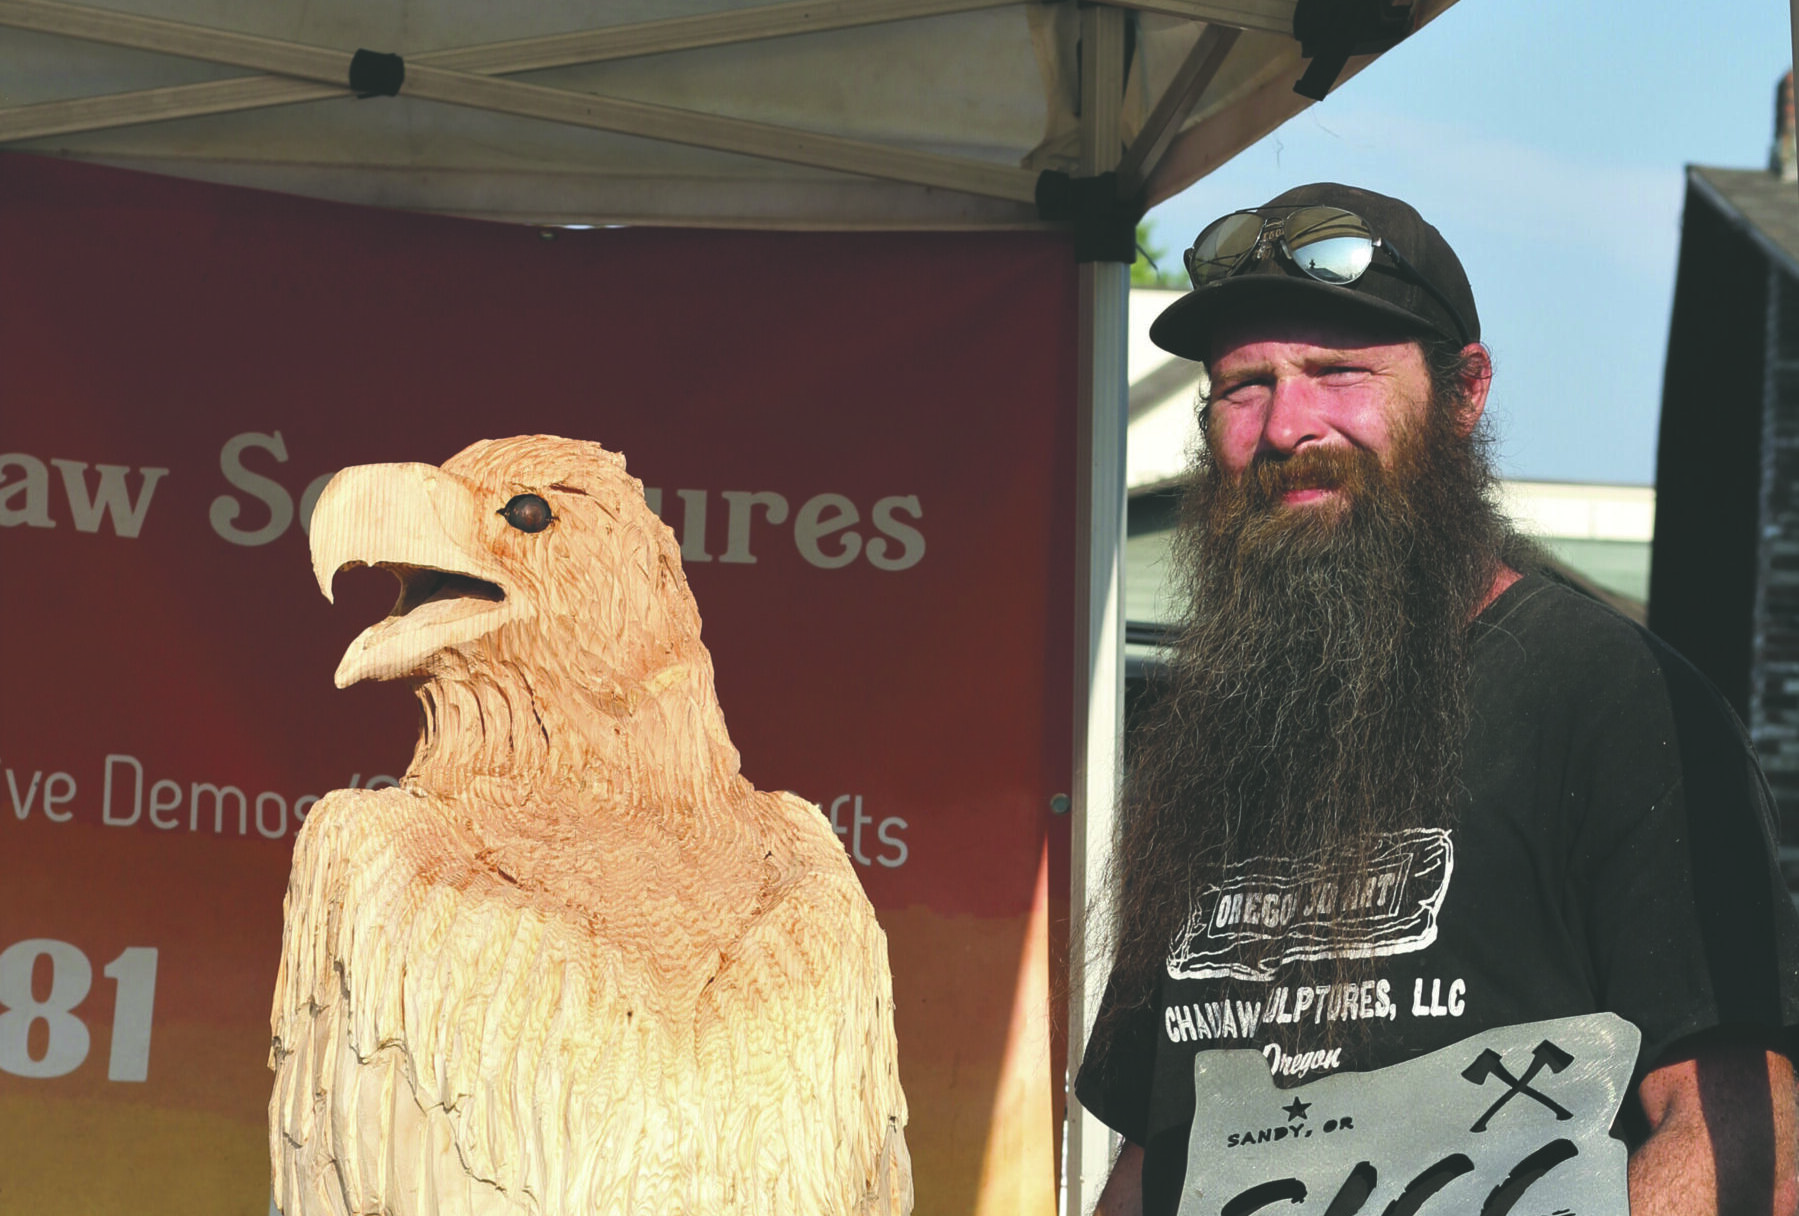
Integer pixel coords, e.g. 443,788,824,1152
700,795,912,1216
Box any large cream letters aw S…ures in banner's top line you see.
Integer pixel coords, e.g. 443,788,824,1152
0,430,925,572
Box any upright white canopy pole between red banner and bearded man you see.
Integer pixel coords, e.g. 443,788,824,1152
1061,5,1130,1216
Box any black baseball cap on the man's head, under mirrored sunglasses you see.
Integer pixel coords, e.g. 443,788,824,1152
1150,182,1481,362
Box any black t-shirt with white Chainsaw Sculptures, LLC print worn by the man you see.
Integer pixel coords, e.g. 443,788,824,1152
1076,576,1799,1216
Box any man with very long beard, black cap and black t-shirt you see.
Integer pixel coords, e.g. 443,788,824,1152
1078,183,1799,1216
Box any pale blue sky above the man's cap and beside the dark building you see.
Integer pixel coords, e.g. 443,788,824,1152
1148,0,1792,484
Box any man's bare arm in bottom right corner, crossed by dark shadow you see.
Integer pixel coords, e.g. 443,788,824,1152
1630,1043,1799,1216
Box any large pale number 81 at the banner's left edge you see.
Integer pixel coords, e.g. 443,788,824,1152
0,937,157,1081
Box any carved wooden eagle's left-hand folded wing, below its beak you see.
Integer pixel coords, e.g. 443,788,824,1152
268,790,546,1216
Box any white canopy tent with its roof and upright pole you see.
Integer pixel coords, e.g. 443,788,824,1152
0,0,1454,1214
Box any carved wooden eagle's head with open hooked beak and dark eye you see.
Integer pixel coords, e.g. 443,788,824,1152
311,435,736,788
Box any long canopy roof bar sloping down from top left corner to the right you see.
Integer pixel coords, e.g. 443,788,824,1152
0,0,1036,203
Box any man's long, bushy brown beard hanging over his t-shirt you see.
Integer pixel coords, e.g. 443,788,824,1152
1101,386,1509,1029
